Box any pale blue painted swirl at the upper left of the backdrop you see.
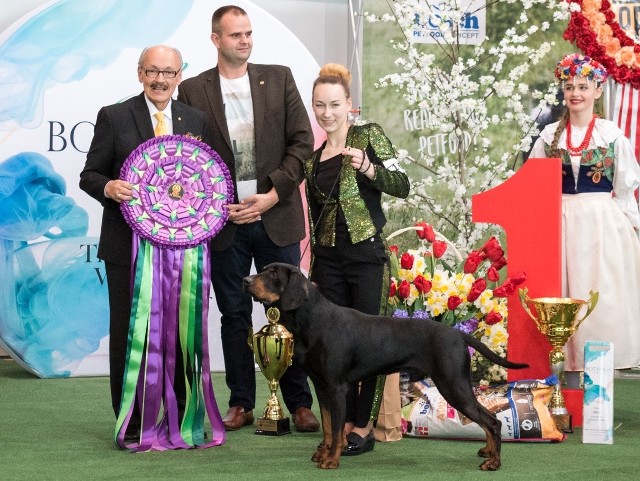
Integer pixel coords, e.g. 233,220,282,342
0,0,193,128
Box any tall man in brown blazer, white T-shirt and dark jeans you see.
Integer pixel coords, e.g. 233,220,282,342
178,5,319,431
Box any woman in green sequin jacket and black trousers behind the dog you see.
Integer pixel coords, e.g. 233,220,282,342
304,64,409,455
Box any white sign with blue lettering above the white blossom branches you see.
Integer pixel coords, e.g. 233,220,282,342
411,0,487,45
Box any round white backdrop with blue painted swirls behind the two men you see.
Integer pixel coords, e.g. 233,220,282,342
0,0,319,377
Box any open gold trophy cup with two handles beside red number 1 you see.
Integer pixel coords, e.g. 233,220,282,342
519,288,598,433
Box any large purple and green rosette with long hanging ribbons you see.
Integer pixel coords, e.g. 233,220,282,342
115,135,233,451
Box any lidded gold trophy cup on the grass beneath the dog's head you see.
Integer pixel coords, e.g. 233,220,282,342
249,307,293,436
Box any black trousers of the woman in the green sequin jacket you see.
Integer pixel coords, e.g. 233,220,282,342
311,233,389,428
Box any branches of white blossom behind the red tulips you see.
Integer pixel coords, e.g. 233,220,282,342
364,0,576,251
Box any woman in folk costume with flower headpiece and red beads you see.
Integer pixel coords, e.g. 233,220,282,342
532,54,640,387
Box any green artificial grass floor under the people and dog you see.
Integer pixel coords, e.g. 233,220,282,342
0,360,640,481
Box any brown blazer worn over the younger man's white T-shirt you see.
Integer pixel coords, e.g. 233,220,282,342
178,64,313,250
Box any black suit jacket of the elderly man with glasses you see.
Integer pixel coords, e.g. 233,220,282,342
80,93,205,265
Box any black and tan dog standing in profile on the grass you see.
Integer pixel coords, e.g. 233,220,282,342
244,264,527,471
